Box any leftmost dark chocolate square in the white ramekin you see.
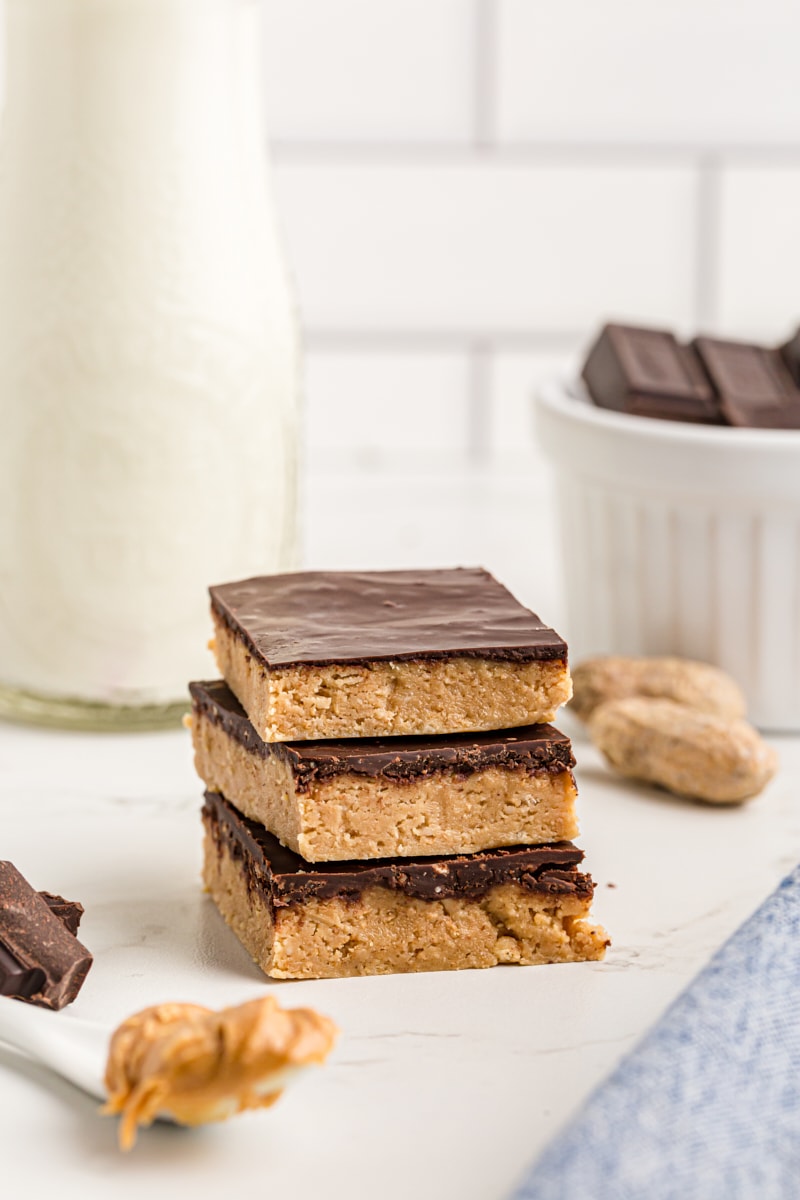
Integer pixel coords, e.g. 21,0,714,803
583,324,720,424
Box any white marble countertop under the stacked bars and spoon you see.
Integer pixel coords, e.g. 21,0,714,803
0,463,800,1200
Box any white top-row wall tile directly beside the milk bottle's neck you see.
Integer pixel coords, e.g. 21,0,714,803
264,0,475,143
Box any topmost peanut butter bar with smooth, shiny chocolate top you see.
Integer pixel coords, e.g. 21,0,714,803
210,569,571,742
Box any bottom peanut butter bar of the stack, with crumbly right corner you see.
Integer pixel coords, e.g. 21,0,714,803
203,792,608,979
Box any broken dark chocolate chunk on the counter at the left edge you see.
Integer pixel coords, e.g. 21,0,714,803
0,862,92,1008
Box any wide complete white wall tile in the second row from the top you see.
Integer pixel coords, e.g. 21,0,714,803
278,163,694,334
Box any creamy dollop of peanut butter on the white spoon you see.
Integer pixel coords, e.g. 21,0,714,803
103,996,338,1150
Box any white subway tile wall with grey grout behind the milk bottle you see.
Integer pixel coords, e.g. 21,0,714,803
263,0,800,477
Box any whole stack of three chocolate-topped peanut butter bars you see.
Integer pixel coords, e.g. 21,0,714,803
190,569,608,979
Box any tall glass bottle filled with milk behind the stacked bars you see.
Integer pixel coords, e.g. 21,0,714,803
0,0,299,728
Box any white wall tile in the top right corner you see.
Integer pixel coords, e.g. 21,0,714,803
497,0,800,146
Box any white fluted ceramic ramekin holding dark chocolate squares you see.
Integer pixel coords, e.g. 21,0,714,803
536,383,800,731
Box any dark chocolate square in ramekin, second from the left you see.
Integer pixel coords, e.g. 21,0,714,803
694,337,800,430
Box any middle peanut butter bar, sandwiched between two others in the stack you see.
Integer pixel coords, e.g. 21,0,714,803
190,683,578,863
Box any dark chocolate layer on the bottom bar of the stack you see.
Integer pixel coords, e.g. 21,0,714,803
203,792,594,908
